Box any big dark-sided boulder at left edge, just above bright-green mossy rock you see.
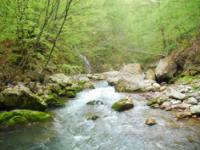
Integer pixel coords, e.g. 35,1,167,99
0,85,47,110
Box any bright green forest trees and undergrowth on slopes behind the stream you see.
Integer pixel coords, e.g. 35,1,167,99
0,0,200,77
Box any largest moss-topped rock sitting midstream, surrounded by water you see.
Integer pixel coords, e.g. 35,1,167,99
112,98,134,111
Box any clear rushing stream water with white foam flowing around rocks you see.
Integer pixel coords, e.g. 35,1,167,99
0,82,200,150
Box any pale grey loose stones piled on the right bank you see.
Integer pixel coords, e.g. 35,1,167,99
147,85,200,119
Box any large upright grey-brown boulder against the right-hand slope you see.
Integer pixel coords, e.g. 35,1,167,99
155,56,177,82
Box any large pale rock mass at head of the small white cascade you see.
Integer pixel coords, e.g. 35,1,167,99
104,64,160,92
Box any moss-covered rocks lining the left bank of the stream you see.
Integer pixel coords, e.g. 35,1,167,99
0,74,93,128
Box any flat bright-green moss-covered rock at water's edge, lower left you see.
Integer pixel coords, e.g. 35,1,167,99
0,110,51,129
